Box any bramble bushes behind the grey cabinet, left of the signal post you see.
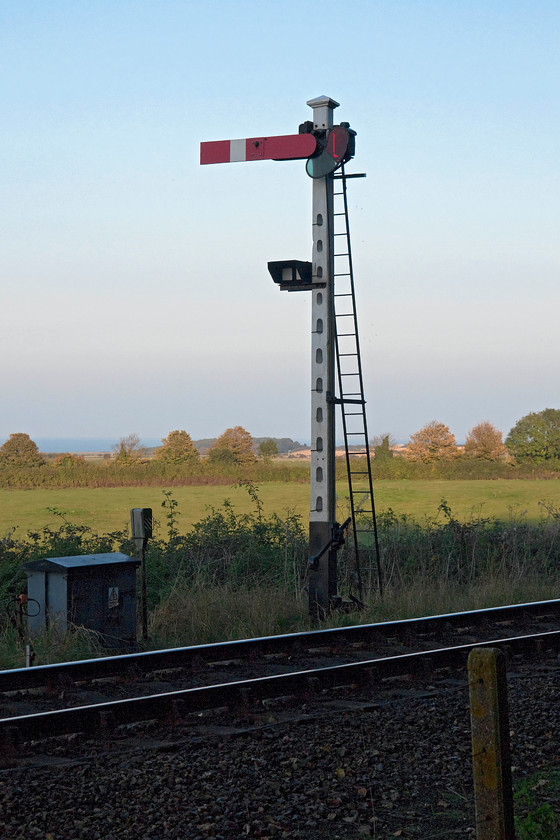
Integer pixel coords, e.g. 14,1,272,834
0,492,307,608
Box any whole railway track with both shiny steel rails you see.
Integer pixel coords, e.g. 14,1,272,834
0,600,560,744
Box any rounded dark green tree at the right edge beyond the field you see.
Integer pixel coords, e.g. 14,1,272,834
505,408,560,467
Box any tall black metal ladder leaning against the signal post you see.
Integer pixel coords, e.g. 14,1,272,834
333,165,383,600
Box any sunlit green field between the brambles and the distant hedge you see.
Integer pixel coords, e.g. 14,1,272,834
4,479,560,537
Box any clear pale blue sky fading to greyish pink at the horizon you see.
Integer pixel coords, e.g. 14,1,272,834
0,0,560,442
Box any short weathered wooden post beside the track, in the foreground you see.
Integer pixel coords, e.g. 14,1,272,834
468,648,515,840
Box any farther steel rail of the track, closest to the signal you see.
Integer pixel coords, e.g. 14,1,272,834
4,599,560,693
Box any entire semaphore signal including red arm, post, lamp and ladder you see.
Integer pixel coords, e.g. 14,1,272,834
200,96,381,618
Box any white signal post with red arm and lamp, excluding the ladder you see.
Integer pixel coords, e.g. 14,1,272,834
200,96,355,618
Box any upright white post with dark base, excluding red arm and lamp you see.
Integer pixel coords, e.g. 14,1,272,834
307,96,339,618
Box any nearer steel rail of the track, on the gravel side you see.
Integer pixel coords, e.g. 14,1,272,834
0,630,560,747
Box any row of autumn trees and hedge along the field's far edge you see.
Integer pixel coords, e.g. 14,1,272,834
0,408,560,487
